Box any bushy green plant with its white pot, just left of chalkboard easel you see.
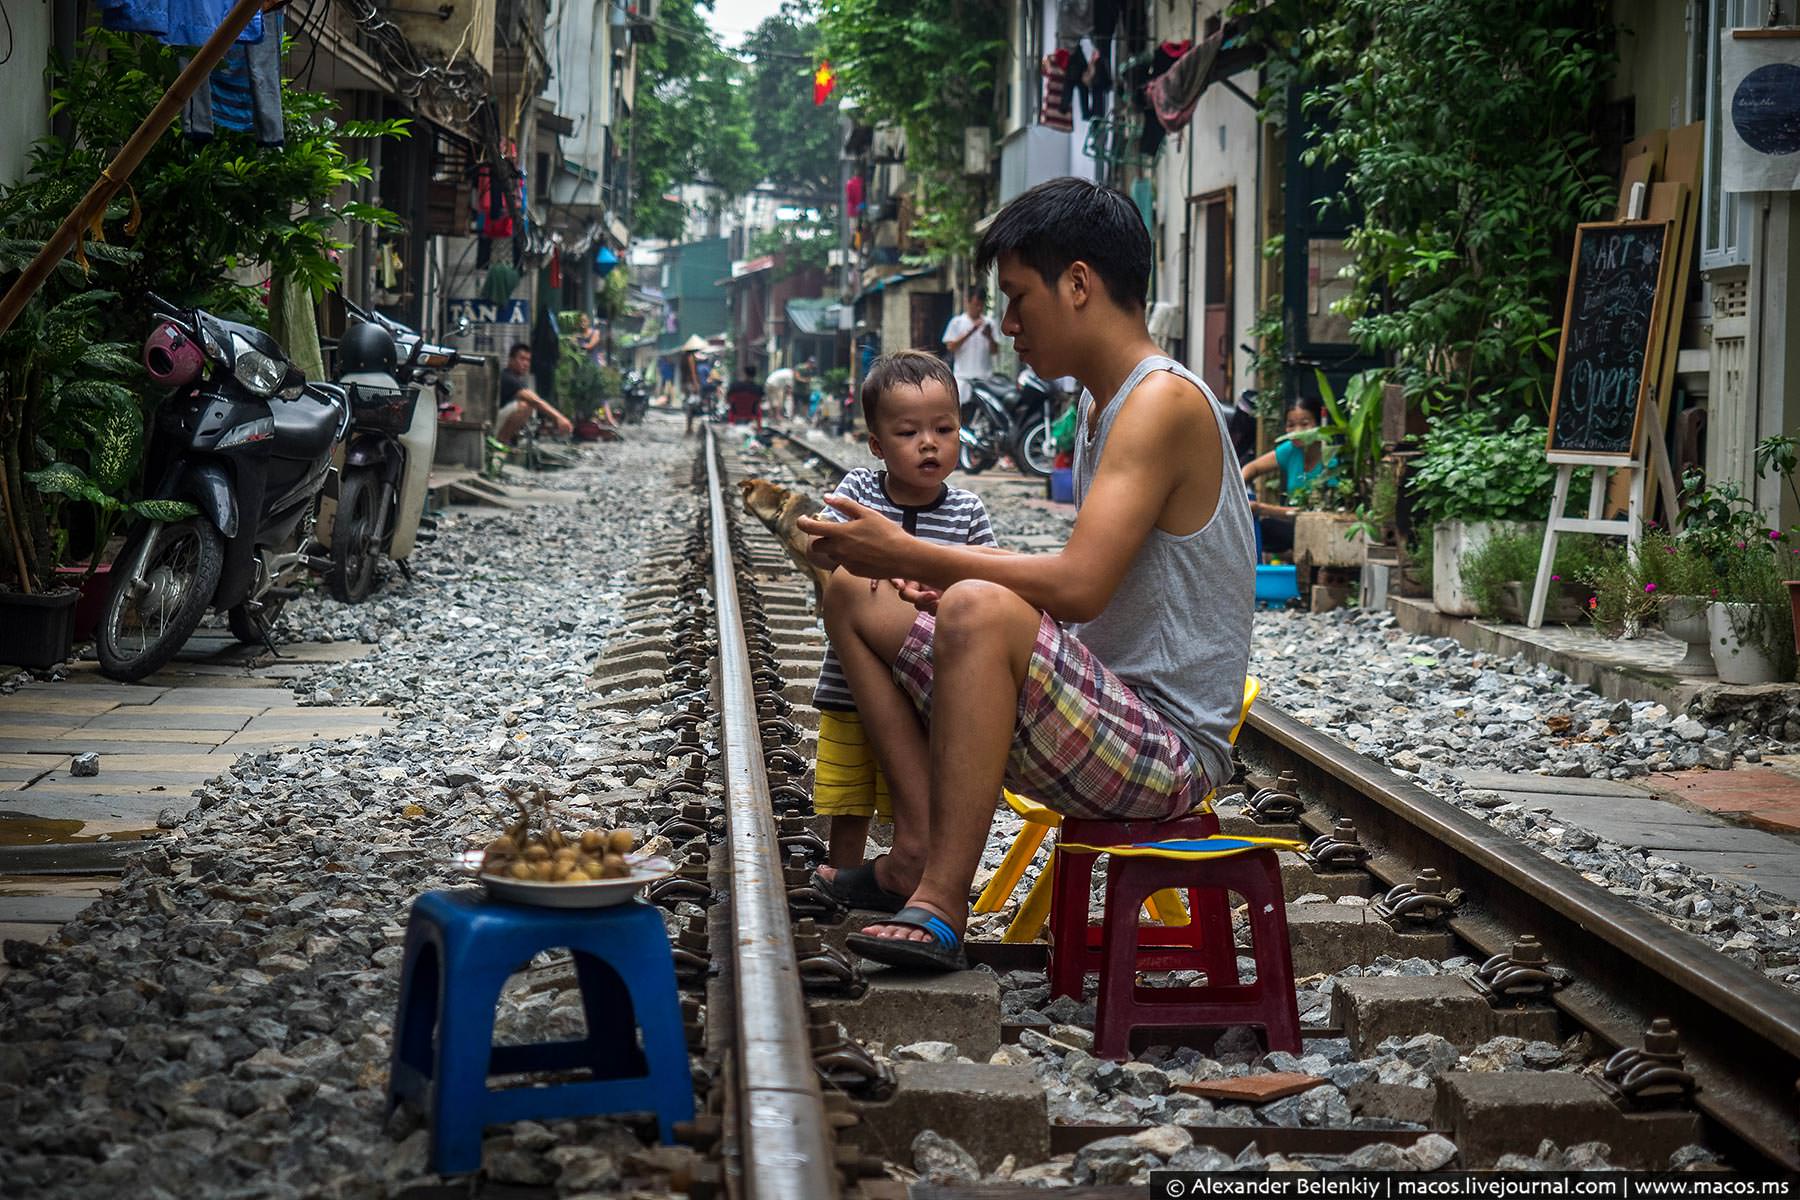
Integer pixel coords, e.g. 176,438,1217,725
1408,412,1553,617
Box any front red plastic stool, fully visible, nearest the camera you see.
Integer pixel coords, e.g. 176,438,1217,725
1094,849,1300,1058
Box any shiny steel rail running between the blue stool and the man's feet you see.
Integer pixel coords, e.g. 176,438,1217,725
706,426,839,1200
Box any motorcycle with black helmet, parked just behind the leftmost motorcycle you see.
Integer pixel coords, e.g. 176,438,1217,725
320,297,484,604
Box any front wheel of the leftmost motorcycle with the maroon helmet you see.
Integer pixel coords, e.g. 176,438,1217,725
94,516,225,684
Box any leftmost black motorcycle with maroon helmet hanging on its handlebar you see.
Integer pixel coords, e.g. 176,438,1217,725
95,295,349,680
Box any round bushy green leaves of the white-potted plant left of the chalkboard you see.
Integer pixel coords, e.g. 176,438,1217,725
1408,414,1555,524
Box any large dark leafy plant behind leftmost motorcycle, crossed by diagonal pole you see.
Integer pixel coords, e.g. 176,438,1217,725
0,27,407,590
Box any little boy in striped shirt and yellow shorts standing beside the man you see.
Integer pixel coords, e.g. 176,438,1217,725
808,351,994,912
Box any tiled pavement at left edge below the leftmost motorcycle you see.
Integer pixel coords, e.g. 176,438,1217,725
0,631,391,975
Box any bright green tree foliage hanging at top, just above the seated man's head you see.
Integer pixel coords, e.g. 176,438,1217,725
819,0,1006,261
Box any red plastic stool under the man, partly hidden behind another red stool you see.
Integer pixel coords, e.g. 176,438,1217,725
1048,810,1237,1000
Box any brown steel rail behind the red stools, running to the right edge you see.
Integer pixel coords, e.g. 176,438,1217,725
1244,702,1800,1171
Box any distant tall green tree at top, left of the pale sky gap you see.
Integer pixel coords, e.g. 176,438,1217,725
630,0,760,241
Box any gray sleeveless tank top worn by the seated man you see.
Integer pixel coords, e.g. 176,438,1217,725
1075,354,1256,784
